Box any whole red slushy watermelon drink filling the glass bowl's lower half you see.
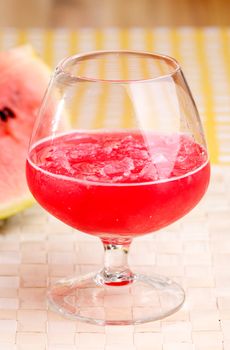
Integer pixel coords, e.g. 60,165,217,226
27,132,210,244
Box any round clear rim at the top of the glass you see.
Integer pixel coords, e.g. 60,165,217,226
56,50,181,84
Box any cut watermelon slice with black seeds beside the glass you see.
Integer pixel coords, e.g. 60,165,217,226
0,46,50,219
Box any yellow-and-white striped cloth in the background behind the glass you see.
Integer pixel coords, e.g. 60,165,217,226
0,27,230,164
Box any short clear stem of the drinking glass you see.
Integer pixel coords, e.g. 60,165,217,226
96,243,135,286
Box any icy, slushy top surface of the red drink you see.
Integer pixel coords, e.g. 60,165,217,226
31,133,207,183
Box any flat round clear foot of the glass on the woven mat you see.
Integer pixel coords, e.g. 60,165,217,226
48,274,185,325
